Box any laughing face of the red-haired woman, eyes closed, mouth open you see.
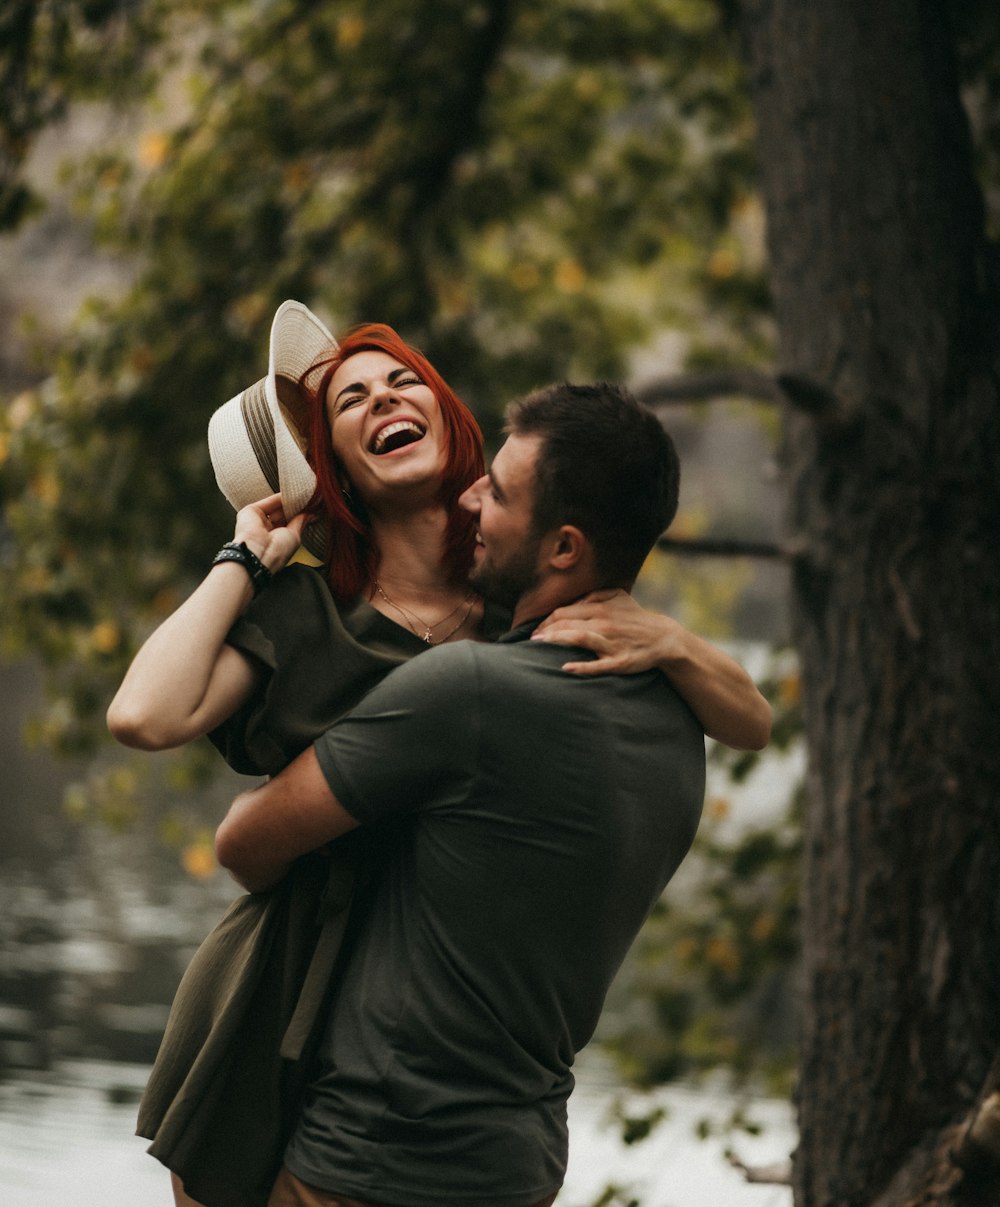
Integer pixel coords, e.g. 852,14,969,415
327,351,445,511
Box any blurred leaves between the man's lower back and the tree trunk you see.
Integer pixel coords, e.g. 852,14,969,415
602,654,802,1095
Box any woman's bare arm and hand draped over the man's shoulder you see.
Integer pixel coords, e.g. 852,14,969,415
533,591,771,751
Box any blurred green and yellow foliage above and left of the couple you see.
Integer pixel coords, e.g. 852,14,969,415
0,0,760,753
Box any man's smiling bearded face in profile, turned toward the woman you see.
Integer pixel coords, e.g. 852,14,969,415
458,436,542,608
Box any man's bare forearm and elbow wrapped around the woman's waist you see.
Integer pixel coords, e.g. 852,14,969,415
215,747,358,893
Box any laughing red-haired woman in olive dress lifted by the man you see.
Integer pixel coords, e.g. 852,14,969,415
109,303,767,1207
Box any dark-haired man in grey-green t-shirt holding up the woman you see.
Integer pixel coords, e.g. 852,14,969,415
216,385,704,1207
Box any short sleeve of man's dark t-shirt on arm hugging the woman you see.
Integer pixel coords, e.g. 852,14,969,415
314,641,479,823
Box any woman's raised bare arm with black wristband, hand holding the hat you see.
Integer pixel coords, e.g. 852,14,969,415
107,495,305,751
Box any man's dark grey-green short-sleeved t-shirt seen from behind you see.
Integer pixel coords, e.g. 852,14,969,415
288,631,704,1207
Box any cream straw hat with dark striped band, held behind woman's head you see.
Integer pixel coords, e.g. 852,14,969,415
209,301,338,559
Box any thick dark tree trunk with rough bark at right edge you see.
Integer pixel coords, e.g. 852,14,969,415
741,0,1000,1207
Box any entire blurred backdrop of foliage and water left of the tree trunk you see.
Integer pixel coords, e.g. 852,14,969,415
0,0,801,1207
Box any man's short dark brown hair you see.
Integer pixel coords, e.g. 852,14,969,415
507,381,680,587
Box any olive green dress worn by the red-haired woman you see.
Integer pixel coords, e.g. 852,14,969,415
136,565,505,1207
